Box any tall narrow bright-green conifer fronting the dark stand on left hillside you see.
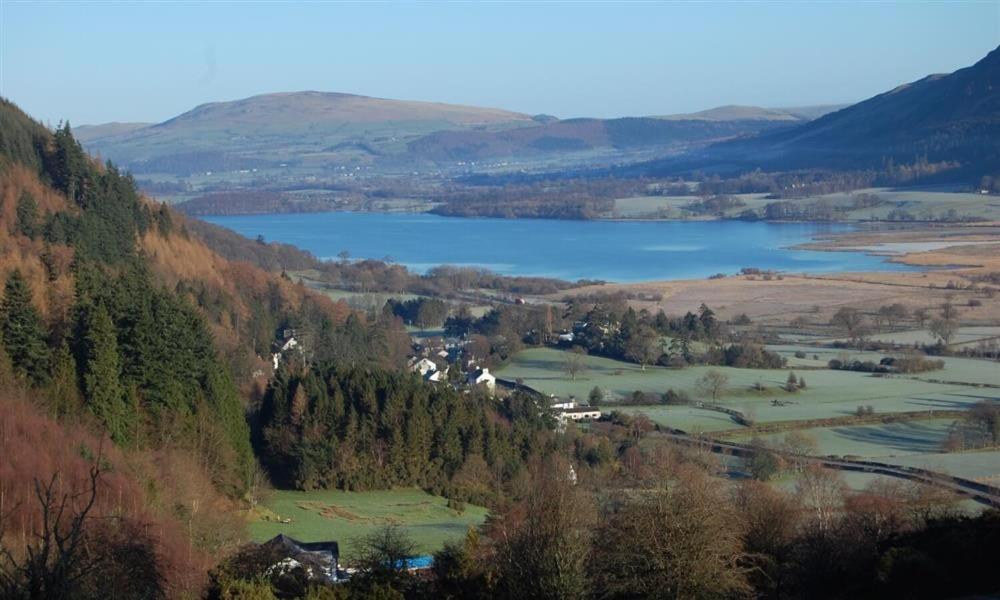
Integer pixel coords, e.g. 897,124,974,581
83,306,132,444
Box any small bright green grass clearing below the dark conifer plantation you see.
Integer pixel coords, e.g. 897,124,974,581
249,489,487,560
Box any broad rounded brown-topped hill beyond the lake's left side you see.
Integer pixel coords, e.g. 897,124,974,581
81,92,535,176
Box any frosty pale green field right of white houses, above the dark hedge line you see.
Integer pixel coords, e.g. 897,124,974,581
497,348,1000,431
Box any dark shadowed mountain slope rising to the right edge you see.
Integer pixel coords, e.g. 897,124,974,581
684,48,1000,173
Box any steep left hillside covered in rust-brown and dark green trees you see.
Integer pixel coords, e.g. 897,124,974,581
0,99,418,598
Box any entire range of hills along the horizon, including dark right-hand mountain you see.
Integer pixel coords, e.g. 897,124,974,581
77,49,1000,184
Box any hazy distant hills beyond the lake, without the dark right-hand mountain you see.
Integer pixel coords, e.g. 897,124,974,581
75,92,836,176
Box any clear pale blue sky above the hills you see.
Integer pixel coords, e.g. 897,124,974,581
0,0,1000,125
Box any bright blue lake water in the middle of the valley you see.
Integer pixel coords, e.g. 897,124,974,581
205,212,908,282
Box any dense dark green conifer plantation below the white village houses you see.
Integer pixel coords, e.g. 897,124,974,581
261,364,553,496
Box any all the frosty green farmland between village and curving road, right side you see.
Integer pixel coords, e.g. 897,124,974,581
498,345,1000,479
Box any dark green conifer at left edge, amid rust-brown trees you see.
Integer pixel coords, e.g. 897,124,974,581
0,270,49,385
